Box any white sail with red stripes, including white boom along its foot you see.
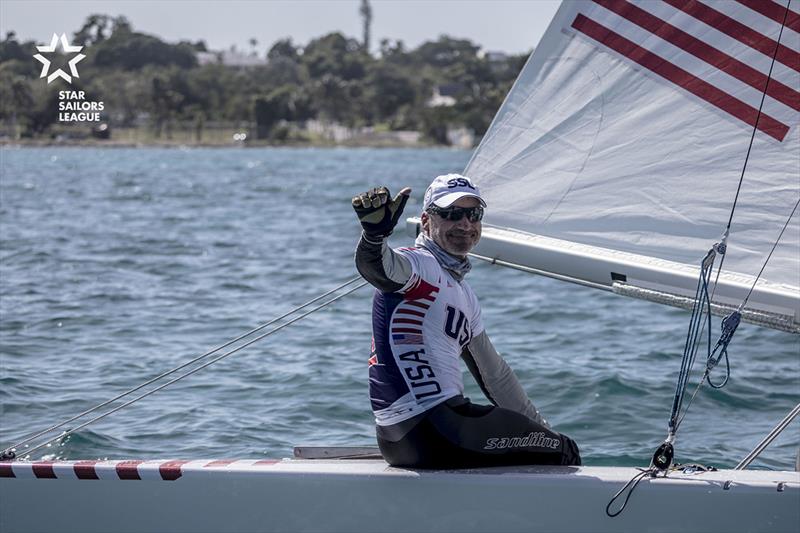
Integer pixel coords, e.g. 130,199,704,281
465,0,800,330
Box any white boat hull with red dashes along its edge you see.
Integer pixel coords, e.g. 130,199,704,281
0,459,800,533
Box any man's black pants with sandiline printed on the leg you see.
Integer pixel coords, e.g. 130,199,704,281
377,396,581,468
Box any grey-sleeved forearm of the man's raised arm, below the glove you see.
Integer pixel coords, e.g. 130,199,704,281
356,233,411,292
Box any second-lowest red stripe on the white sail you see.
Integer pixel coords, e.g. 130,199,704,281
594,0,800,111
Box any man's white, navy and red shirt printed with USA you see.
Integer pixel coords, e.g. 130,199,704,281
369,248,483,426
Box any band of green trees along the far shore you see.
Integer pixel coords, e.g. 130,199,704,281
0,15,527,143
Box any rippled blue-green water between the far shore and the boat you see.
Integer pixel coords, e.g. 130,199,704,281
0,147,800,468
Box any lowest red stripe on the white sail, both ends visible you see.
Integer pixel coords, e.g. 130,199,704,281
572,15,789,141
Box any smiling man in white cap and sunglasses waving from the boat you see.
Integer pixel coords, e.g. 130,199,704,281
352,174,581,468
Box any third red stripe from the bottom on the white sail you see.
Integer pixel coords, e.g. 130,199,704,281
664,0,800,72
